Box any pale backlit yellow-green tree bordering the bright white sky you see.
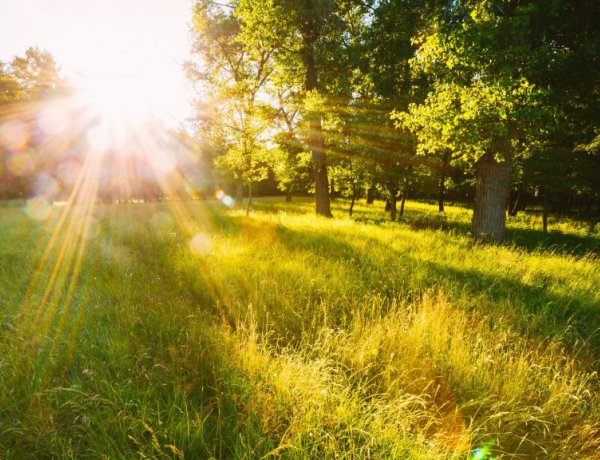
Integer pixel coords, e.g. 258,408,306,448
188,0,278,212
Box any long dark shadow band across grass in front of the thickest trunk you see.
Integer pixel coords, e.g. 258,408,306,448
280,223,600,356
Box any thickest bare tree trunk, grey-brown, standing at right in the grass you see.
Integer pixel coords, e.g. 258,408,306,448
471,153,510,241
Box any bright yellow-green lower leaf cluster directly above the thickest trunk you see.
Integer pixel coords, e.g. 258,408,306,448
392,80,543,165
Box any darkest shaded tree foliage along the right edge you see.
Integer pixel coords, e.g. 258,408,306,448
522,0,600,228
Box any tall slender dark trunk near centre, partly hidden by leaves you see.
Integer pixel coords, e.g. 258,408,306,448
302,20,332,217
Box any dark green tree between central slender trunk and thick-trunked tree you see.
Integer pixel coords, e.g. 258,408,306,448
352,0,443,220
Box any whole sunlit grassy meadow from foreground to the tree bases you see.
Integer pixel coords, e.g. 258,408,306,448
0,199,600,459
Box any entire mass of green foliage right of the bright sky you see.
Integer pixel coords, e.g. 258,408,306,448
184,0,600,221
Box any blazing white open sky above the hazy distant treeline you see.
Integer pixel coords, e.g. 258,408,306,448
0,0,191,123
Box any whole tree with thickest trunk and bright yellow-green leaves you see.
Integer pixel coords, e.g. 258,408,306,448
393,1,545,240
